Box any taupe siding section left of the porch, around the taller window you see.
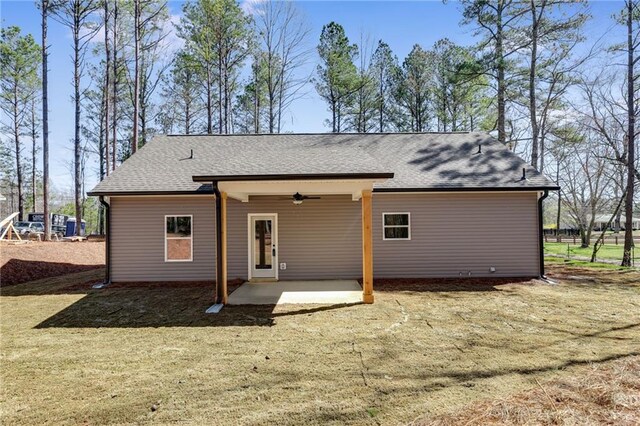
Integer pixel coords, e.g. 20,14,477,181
110,196,216,282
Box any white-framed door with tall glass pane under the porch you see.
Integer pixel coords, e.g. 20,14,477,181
249,214,278,279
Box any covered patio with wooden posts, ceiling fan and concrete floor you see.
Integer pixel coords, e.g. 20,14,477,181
193,173,393,305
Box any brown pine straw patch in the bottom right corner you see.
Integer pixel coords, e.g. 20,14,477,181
413,356,640,426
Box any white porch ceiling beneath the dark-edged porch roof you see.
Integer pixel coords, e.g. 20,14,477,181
218,178,386,203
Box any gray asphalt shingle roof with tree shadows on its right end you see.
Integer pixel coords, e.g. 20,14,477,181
91,132,556,195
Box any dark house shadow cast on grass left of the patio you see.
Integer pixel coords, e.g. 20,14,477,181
35,285,362,329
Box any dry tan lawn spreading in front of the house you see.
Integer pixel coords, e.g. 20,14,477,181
0,265,640,425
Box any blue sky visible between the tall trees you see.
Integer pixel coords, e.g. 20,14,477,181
0,0,623,192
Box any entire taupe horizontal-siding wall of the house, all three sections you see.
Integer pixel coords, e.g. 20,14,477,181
110,192,539,282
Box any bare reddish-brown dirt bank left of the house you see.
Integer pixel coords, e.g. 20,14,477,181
0,242,104,287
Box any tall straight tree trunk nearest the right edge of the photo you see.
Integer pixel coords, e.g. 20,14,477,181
622,0,636,266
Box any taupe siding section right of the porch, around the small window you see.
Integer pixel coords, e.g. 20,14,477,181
373,192,539,278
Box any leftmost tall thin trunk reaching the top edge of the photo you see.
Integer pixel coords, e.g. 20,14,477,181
42,0,51,241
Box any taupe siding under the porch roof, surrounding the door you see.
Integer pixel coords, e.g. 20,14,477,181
227,195,362,280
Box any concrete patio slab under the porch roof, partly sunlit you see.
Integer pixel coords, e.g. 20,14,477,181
228,280,362,305
